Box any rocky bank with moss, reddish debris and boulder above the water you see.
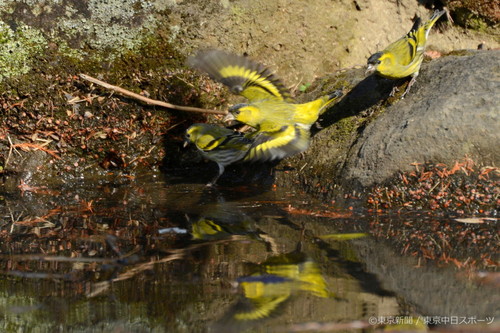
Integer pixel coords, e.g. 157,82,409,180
0,0,500,205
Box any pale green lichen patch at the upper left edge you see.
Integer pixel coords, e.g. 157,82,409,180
0,21,47,81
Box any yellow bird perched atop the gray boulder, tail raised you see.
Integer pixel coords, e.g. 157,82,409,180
366,10,445,98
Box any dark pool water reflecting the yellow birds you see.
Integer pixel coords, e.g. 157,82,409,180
0,177,500,332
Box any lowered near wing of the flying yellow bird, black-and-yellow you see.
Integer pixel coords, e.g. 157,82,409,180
244,125,310,161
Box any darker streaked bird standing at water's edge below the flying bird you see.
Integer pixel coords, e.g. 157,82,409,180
184,124,253,186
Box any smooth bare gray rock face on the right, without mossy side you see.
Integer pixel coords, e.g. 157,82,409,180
343,51,500,186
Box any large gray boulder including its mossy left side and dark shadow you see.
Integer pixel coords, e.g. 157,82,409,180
278,50,500,195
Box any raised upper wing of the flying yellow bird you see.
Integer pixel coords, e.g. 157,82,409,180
189,50,291,102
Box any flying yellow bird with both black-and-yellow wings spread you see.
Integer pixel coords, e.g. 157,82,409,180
189,50,342,161
